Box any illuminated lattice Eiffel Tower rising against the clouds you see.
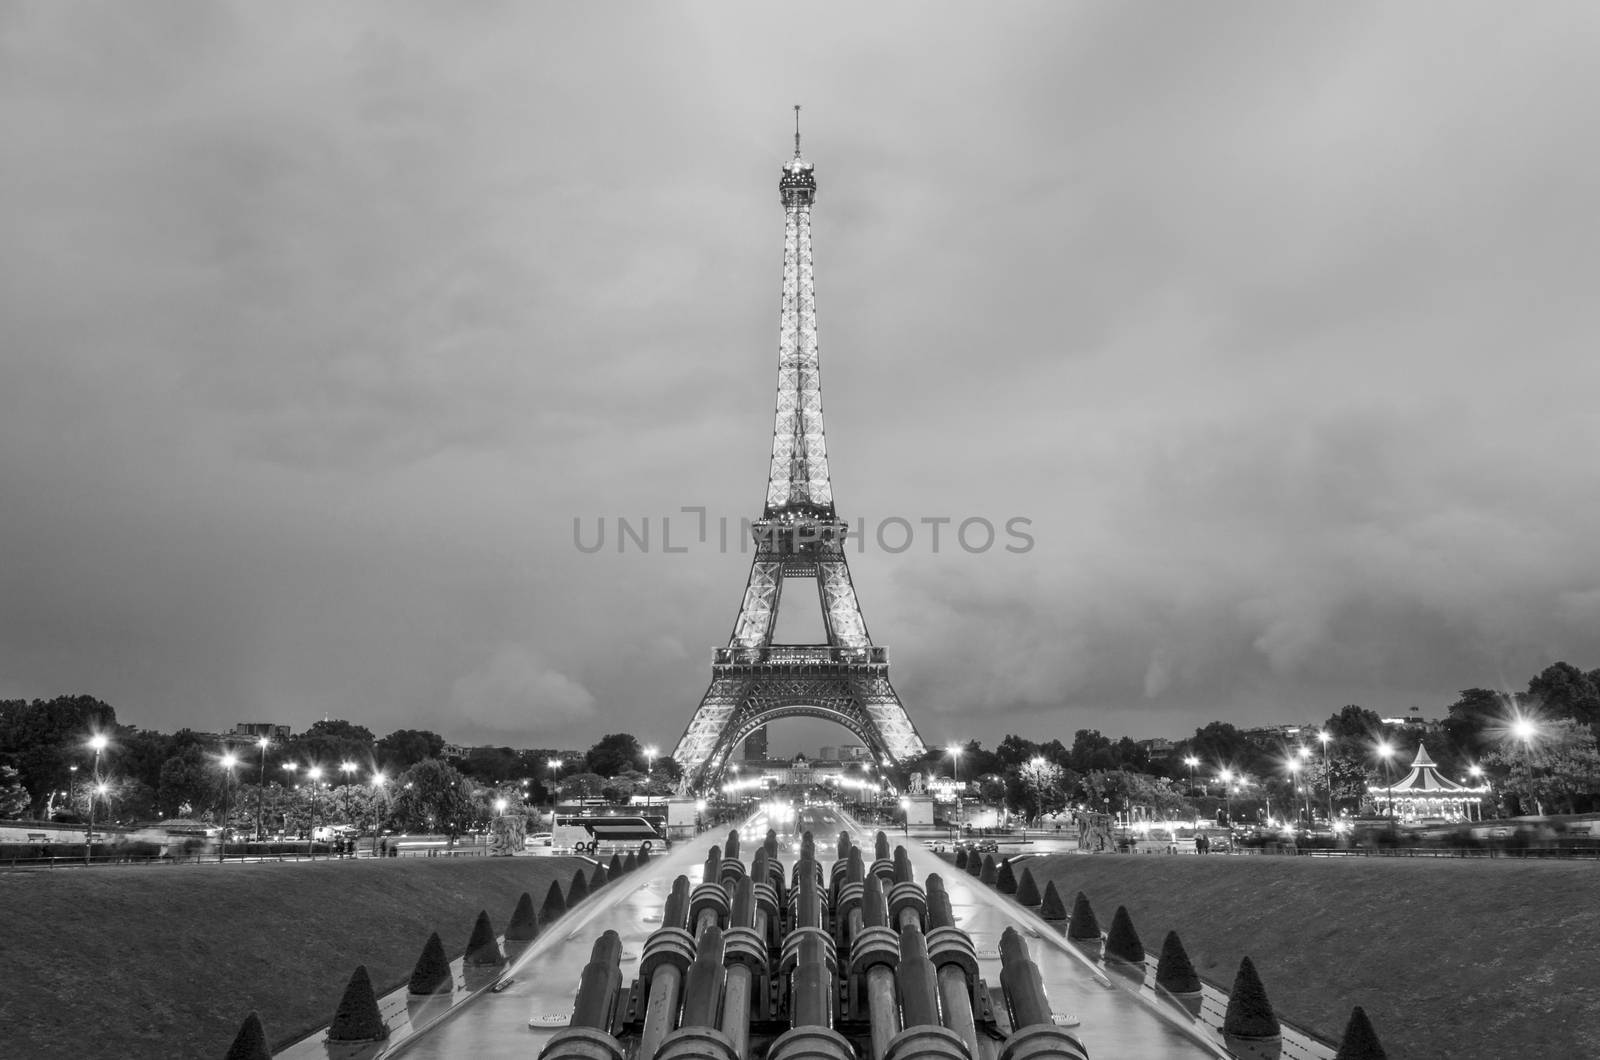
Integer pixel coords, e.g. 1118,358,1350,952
672,107,926,789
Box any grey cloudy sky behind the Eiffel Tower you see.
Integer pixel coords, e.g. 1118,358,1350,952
0,0,1600,758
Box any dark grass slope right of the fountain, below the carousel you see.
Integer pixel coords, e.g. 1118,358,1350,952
1029,855,1600,1060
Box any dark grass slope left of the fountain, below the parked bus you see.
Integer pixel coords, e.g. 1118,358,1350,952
0,858,587,1058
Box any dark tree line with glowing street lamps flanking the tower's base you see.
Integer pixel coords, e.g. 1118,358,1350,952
0,663,1600,828
